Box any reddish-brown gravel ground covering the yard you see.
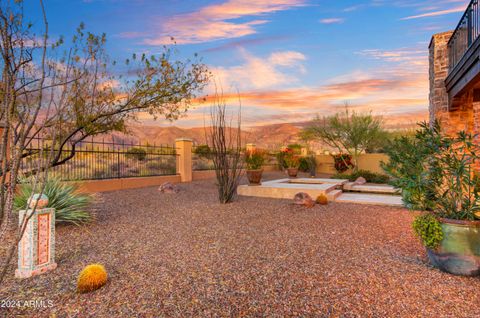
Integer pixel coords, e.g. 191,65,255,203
0,175,480,317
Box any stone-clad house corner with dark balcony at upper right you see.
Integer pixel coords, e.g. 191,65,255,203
429,1,480,135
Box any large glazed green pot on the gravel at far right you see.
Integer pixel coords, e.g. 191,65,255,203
427,219,480,276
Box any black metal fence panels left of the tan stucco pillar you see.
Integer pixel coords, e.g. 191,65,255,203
21,138,177,181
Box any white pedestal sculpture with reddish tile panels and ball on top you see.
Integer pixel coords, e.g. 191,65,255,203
15,195,57,278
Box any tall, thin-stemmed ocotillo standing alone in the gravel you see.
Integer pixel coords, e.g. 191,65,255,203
206,93,243,203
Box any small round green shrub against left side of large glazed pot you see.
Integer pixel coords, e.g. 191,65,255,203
412,213,443,249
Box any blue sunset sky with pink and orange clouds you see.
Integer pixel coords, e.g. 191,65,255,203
27,0,469,127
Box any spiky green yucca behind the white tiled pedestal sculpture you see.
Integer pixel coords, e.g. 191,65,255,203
14,178,93,225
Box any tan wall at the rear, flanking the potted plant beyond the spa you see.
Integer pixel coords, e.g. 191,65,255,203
316,153,388,174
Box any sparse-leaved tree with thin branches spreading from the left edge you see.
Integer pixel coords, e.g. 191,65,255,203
0,0,209,283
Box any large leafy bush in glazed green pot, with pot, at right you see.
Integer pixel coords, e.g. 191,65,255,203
384,123,480,276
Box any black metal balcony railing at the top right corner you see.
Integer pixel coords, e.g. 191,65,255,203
448,0,480,71
